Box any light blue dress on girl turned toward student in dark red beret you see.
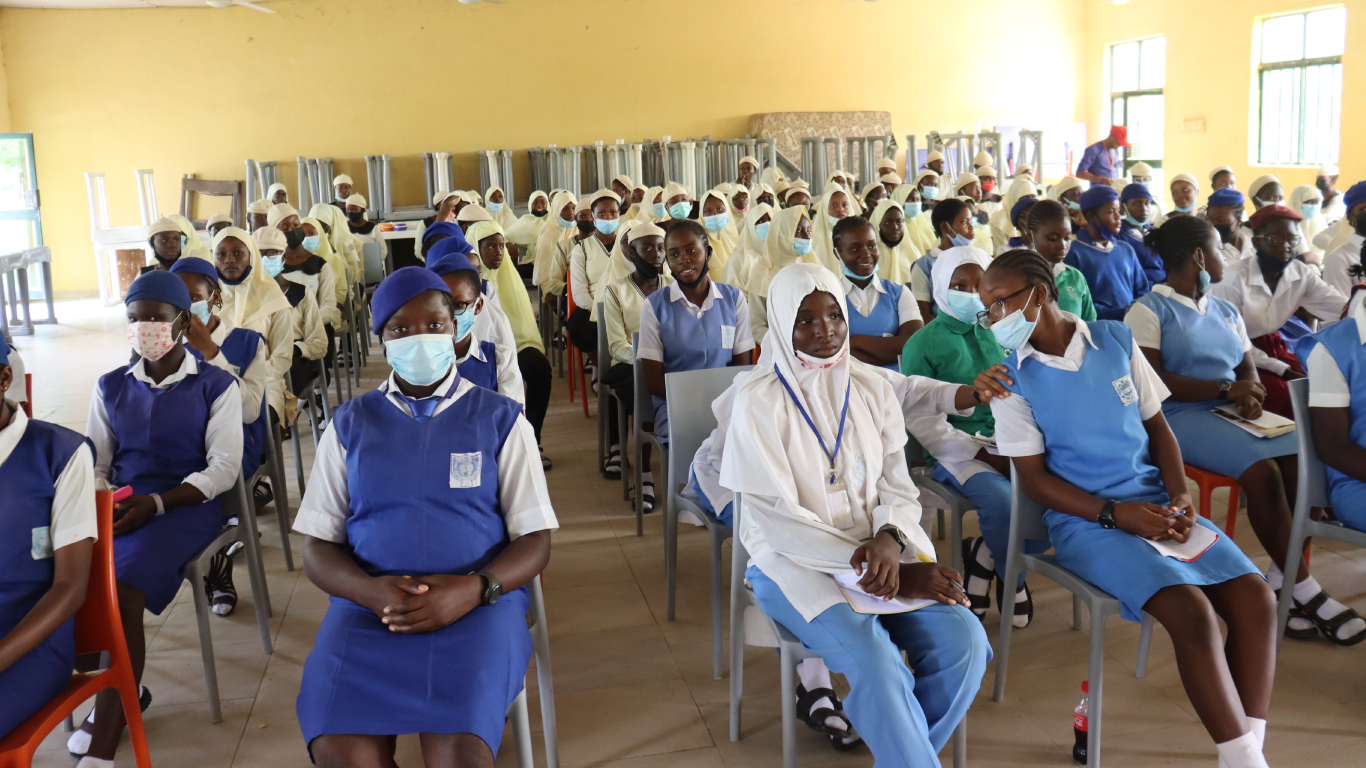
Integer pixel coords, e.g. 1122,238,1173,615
1138,291,1299,480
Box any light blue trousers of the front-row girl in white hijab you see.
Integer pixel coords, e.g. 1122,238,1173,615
744,566,992,768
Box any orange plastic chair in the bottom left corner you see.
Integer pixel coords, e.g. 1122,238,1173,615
0,491,152,768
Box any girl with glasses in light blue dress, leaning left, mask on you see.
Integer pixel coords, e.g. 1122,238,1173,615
977,251,1276,768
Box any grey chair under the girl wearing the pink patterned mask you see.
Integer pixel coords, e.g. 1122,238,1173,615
184,473,275,723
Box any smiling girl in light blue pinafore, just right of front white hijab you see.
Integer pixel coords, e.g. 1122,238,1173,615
832,215,925,370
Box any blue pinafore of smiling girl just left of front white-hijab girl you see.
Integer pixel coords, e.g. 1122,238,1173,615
645,282,740,445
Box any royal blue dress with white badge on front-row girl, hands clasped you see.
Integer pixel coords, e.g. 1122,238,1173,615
298,383,531,756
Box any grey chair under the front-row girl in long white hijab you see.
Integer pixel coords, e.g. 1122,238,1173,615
731,493,967,768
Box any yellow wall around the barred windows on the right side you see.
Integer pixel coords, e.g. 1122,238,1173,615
1083,0,1366,200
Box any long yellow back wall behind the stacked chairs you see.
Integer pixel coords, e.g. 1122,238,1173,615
0,0,1090,291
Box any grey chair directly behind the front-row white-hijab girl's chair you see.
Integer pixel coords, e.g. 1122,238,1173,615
664,365,754,672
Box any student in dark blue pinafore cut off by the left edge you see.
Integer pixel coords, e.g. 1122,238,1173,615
0,333,98,738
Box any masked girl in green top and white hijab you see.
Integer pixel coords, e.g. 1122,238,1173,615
902,246,1046,627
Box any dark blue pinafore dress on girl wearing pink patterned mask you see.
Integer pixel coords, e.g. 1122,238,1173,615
100,365,236,614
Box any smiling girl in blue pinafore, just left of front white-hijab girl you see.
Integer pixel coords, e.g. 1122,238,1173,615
635,221,754,445
